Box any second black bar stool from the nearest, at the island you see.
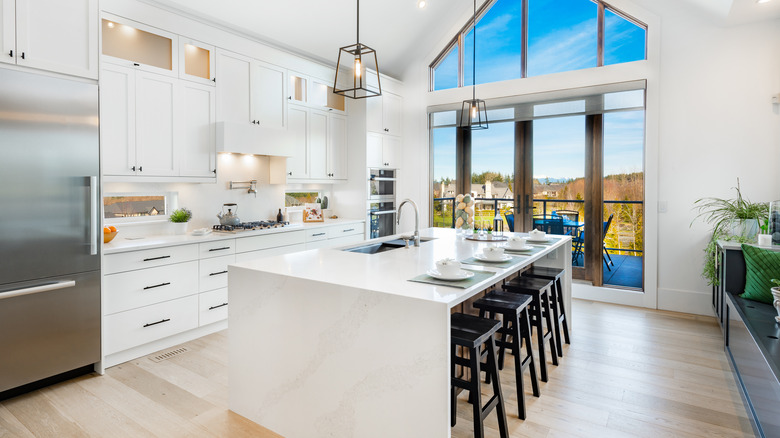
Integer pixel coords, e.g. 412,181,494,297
474,291,539,420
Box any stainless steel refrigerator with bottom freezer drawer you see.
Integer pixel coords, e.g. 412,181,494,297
0,68,102,399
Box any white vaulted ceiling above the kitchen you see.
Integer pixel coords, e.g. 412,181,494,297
147,0,780,78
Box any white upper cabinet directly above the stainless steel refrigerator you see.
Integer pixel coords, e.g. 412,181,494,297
0,0,98,79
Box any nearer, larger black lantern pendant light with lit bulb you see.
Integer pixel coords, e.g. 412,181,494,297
333,0,382,99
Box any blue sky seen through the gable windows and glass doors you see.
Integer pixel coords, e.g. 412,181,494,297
433,0,646,180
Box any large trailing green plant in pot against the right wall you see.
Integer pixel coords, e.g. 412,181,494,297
691,178,769,286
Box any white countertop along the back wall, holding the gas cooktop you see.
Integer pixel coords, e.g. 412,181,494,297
103,219,365,254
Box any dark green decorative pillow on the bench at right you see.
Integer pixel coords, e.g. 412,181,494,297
740,243,780,304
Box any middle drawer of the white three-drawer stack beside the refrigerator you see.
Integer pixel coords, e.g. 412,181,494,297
103,261,198,315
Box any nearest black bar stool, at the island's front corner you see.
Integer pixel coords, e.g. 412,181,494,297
450,313,509,438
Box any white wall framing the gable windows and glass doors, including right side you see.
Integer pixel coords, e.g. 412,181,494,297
402,0,780,314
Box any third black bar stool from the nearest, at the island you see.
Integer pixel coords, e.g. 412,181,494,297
504,277,558,382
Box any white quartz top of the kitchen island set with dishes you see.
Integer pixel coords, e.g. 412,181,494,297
231,228,571,307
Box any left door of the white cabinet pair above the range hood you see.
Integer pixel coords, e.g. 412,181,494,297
216,49,252,123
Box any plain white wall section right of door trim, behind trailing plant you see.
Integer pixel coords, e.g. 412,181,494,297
658,15,780,314
